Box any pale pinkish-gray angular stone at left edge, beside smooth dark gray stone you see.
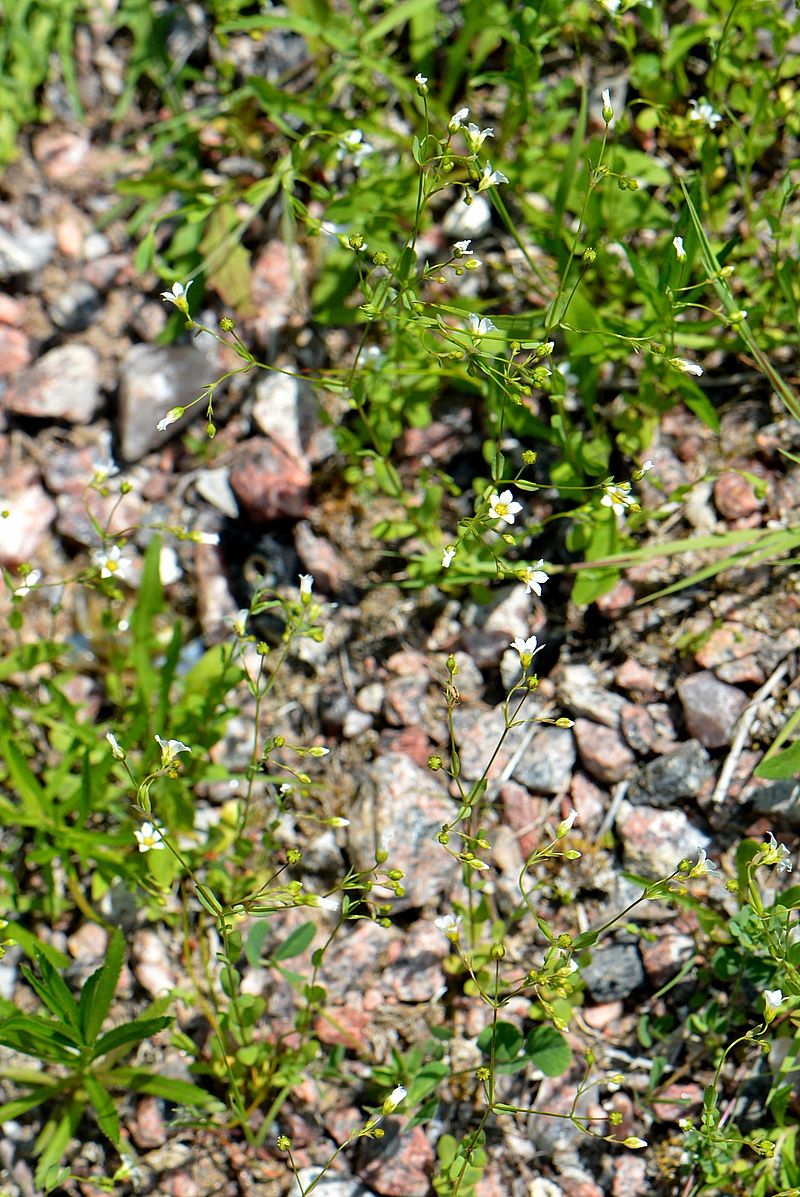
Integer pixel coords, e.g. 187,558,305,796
4,345,99,424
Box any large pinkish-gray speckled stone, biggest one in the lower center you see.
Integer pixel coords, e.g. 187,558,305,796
347,753,456,910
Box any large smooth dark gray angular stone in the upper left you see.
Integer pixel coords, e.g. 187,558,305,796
119,345,213,461
